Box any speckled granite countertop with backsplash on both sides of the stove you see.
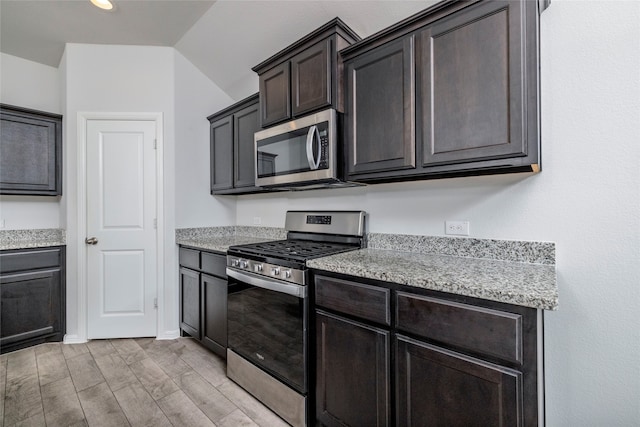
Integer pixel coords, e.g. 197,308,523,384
176,226,558,310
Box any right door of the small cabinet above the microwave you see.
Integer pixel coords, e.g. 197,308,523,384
291,39,332,117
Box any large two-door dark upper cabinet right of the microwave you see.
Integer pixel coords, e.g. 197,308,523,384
340,0,542,182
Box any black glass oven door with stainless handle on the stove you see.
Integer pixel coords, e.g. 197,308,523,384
227,267,309,394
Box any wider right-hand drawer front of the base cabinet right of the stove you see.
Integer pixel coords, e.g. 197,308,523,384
396,292,523,363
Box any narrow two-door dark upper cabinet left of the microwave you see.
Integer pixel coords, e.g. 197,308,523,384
208,94,262,194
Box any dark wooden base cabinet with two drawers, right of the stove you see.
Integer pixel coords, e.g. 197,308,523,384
314,272,544,427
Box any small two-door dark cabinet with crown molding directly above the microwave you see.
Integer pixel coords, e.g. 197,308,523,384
252,18,360,127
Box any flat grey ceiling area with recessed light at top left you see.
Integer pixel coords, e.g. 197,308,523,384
0,0,214,67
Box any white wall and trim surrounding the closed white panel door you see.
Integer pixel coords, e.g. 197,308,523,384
61,44,178,339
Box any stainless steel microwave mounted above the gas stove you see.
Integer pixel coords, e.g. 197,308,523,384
254,109,356,190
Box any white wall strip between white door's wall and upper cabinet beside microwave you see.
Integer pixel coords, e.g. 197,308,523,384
175,51,236,228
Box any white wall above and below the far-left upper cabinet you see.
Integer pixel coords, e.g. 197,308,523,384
0,53,63,230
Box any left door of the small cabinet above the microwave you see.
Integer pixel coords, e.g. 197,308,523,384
259,61,291,127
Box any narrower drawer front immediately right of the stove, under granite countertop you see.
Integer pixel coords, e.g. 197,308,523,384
315,276,391,325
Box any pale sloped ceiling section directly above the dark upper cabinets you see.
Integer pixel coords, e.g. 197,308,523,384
176,0,437,99
